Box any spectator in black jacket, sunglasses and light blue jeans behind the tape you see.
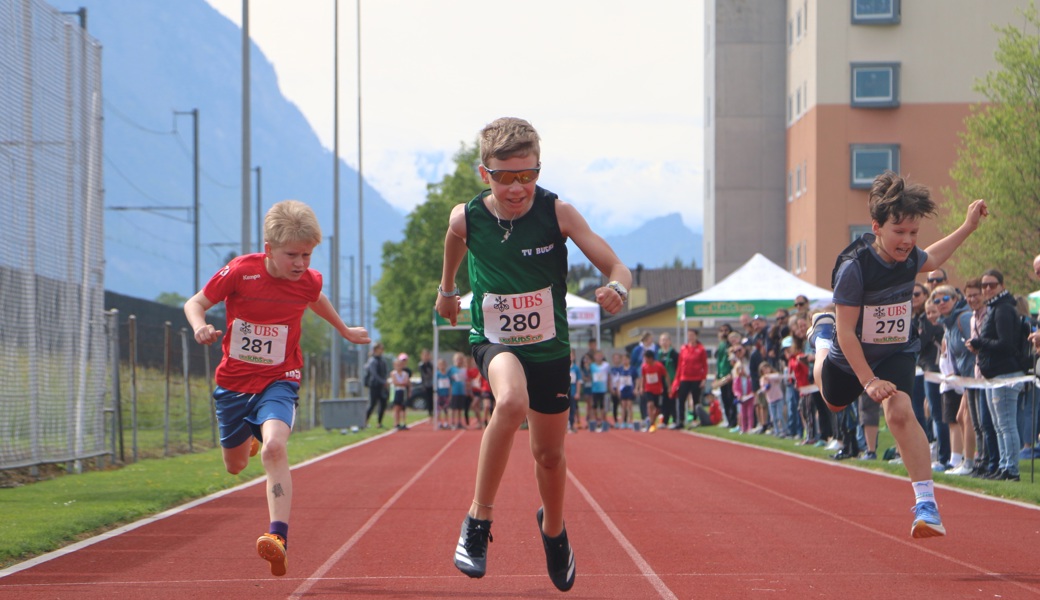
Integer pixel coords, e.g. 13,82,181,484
967,269,1023,481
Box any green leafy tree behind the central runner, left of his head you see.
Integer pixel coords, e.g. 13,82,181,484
372,146,484,357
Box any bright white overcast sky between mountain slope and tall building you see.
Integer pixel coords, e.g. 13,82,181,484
207,0,704,234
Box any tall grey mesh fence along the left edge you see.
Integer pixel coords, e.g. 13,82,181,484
0,0,111,468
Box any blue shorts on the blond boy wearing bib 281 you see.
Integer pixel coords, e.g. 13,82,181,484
213,382,300,448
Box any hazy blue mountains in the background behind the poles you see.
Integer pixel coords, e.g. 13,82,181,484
44,0,701,298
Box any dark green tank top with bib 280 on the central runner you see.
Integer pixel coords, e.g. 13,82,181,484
466,187,570,362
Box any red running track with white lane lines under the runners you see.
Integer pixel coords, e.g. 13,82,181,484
0,424,1040,600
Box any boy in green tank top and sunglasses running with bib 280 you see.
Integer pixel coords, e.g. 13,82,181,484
437,118,631,592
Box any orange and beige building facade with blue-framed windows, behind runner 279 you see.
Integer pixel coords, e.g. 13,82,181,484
785,0,1026,287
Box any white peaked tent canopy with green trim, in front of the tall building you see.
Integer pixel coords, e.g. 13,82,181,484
676,253,833,321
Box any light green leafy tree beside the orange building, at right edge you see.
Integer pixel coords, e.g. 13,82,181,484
941,2,1040,293
